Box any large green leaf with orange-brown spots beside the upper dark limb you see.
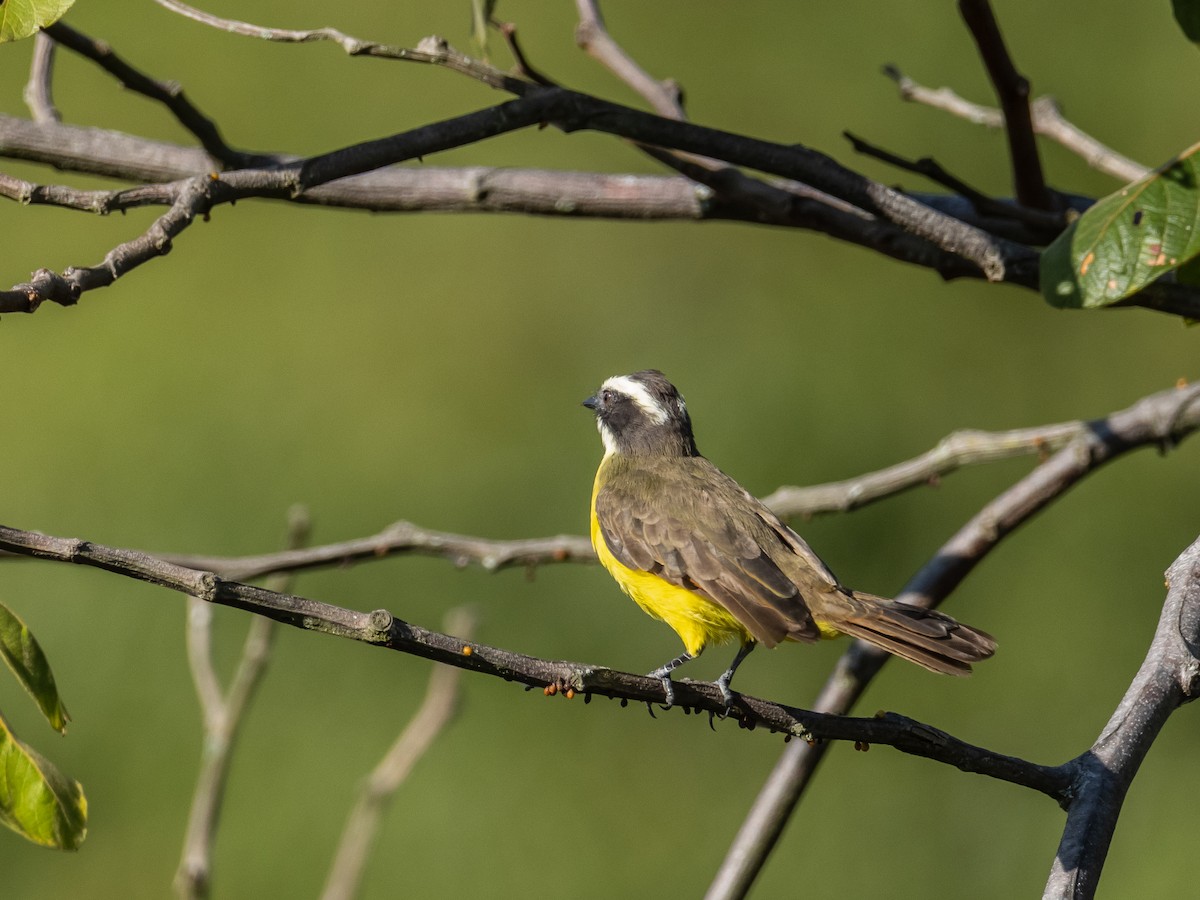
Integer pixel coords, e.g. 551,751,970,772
1040,144,1200,310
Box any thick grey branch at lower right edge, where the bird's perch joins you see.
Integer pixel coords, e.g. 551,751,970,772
1043,539,1200,900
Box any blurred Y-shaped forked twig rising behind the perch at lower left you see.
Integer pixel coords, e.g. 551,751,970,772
175,506,310,900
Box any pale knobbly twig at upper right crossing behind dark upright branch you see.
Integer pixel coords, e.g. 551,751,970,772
883,66,1150,182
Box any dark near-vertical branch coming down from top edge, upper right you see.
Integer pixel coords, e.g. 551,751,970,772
959,0,1058,212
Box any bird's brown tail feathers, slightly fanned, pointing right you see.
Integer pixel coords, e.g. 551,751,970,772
814,590,996,676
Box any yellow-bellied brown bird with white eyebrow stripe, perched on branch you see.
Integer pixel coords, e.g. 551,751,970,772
583,368,996,708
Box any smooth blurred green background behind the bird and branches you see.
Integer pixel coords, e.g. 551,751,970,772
0,0,1200,899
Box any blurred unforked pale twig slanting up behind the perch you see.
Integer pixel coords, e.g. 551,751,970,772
322,607,475,900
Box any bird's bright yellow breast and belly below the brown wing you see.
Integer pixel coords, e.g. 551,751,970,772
592,482,751,656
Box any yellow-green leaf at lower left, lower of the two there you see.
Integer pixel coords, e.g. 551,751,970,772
0,716,88,850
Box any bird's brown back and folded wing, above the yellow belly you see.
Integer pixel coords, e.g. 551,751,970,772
596,457,836,647
